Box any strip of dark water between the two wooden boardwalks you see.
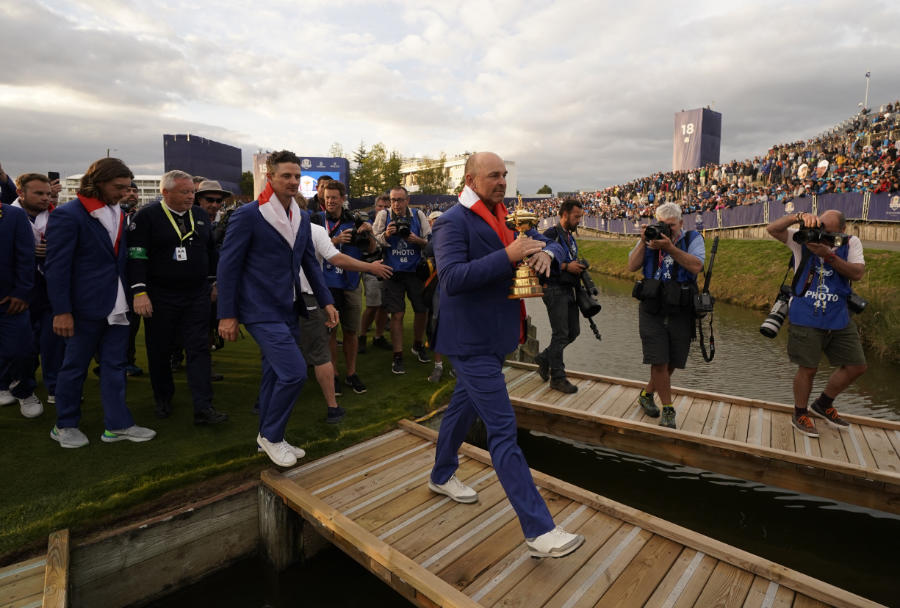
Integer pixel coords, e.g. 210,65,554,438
519,430,900,606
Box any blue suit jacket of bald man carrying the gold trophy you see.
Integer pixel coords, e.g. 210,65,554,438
432,204,563,356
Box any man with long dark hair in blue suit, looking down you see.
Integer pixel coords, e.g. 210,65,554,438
44,158,156,448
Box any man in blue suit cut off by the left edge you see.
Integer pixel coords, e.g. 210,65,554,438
0,203,37,418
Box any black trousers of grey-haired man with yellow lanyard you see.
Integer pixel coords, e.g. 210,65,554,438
144,284,212,412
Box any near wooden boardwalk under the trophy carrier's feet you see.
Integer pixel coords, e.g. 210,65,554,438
262,422,877,608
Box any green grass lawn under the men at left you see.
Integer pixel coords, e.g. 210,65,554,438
0,313,452,563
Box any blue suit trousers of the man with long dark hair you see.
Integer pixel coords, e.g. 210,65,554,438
56,317,134,431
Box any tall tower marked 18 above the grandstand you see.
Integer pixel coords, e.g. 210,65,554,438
672,107,722,171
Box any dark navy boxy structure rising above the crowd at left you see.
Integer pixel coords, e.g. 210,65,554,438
163,134,241,194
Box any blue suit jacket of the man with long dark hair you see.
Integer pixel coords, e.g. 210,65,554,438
44,199,128,321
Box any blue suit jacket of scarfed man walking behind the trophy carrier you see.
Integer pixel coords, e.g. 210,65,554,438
216,201,334,323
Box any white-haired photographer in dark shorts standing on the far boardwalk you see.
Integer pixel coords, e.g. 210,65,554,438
628,203,706,429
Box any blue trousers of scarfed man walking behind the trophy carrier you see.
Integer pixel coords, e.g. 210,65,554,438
245,321,306,443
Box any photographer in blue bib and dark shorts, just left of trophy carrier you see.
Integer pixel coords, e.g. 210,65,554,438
373,186,431,374
